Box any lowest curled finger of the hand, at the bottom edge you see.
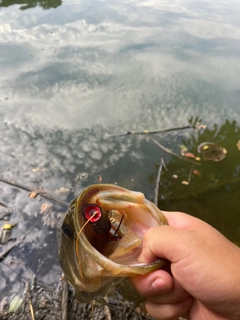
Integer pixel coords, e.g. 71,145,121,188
145,297,193,320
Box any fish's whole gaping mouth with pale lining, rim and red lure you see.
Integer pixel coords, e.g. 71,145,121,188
79,186,165,266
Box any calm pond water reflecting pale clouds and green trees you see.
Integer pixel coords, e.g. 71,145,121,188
0,0,240,302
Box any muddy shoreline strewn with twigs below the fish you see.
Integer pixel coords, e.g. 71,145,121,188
0,279,153,320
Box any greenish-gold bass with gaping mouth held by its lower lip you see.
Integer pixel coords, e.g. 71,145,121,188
58,184,168,301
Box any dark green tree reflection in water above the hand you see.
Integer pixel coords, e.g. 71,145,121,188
151,120,240,242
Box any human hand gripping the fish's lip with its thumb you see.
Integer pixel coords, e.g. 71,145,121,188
131,212,240,320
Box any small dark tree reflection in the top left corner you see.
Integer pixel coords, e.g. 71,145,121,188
0,0,62,10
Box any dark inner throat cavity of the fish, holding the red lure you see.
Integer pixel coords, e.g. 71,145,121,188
80,204,151,265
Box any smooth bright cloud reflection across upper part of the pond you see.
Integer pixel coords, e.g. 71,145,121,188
0,1,240,130
